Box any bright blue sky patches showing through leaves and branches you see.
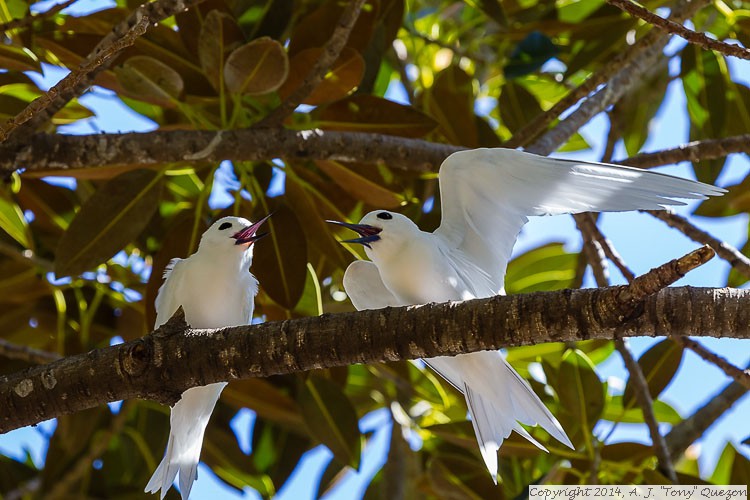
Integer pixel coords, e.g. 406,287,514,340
0,0,750,500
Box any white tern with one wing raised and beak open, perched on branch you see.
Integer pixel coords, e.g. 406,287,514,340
328,148,724,481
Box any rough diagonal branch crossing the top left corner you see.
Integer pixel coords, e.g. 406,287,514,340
0,0,203,142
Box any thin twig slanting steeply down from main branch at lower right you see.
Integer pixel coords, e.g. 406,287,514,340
615,338,678,484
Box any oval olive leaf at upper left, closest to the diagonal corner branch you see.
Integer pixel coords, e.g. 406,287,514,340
115,56,185,107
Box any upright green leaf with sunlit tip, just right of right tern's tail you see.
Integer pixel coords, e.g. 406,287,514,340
556,349,604,432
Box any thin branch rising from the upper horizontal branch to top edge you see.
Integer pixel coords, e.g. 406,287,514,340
257,0,365,127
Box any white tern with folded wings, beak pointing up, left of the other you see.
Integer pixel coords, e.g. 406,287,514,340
145,215,270,500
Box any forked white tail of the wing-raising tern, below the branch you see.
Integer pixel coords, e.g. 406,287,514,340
425,351,573,481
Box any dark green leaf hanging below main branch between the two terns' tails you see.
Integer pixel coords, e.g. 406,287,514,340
297,374,361,469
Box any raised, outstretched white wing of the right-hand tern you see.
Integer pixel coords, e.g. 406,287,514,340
435,148,725,293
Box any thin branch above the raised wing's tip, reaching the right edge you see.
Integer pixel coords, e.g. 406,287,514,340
615,134,750,168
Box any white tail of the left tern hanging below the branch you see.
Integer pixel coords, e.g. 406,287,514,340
144,382,227,500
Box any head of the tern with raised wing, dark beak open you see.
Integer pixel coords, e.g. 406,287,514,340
327,210,420,259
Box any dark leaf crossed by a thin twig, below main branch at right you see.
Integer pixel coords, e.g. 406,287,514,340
623,338,683,408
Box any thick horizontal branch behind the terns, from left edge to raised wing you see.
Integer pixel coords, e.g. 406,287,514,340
0,128,465,173
